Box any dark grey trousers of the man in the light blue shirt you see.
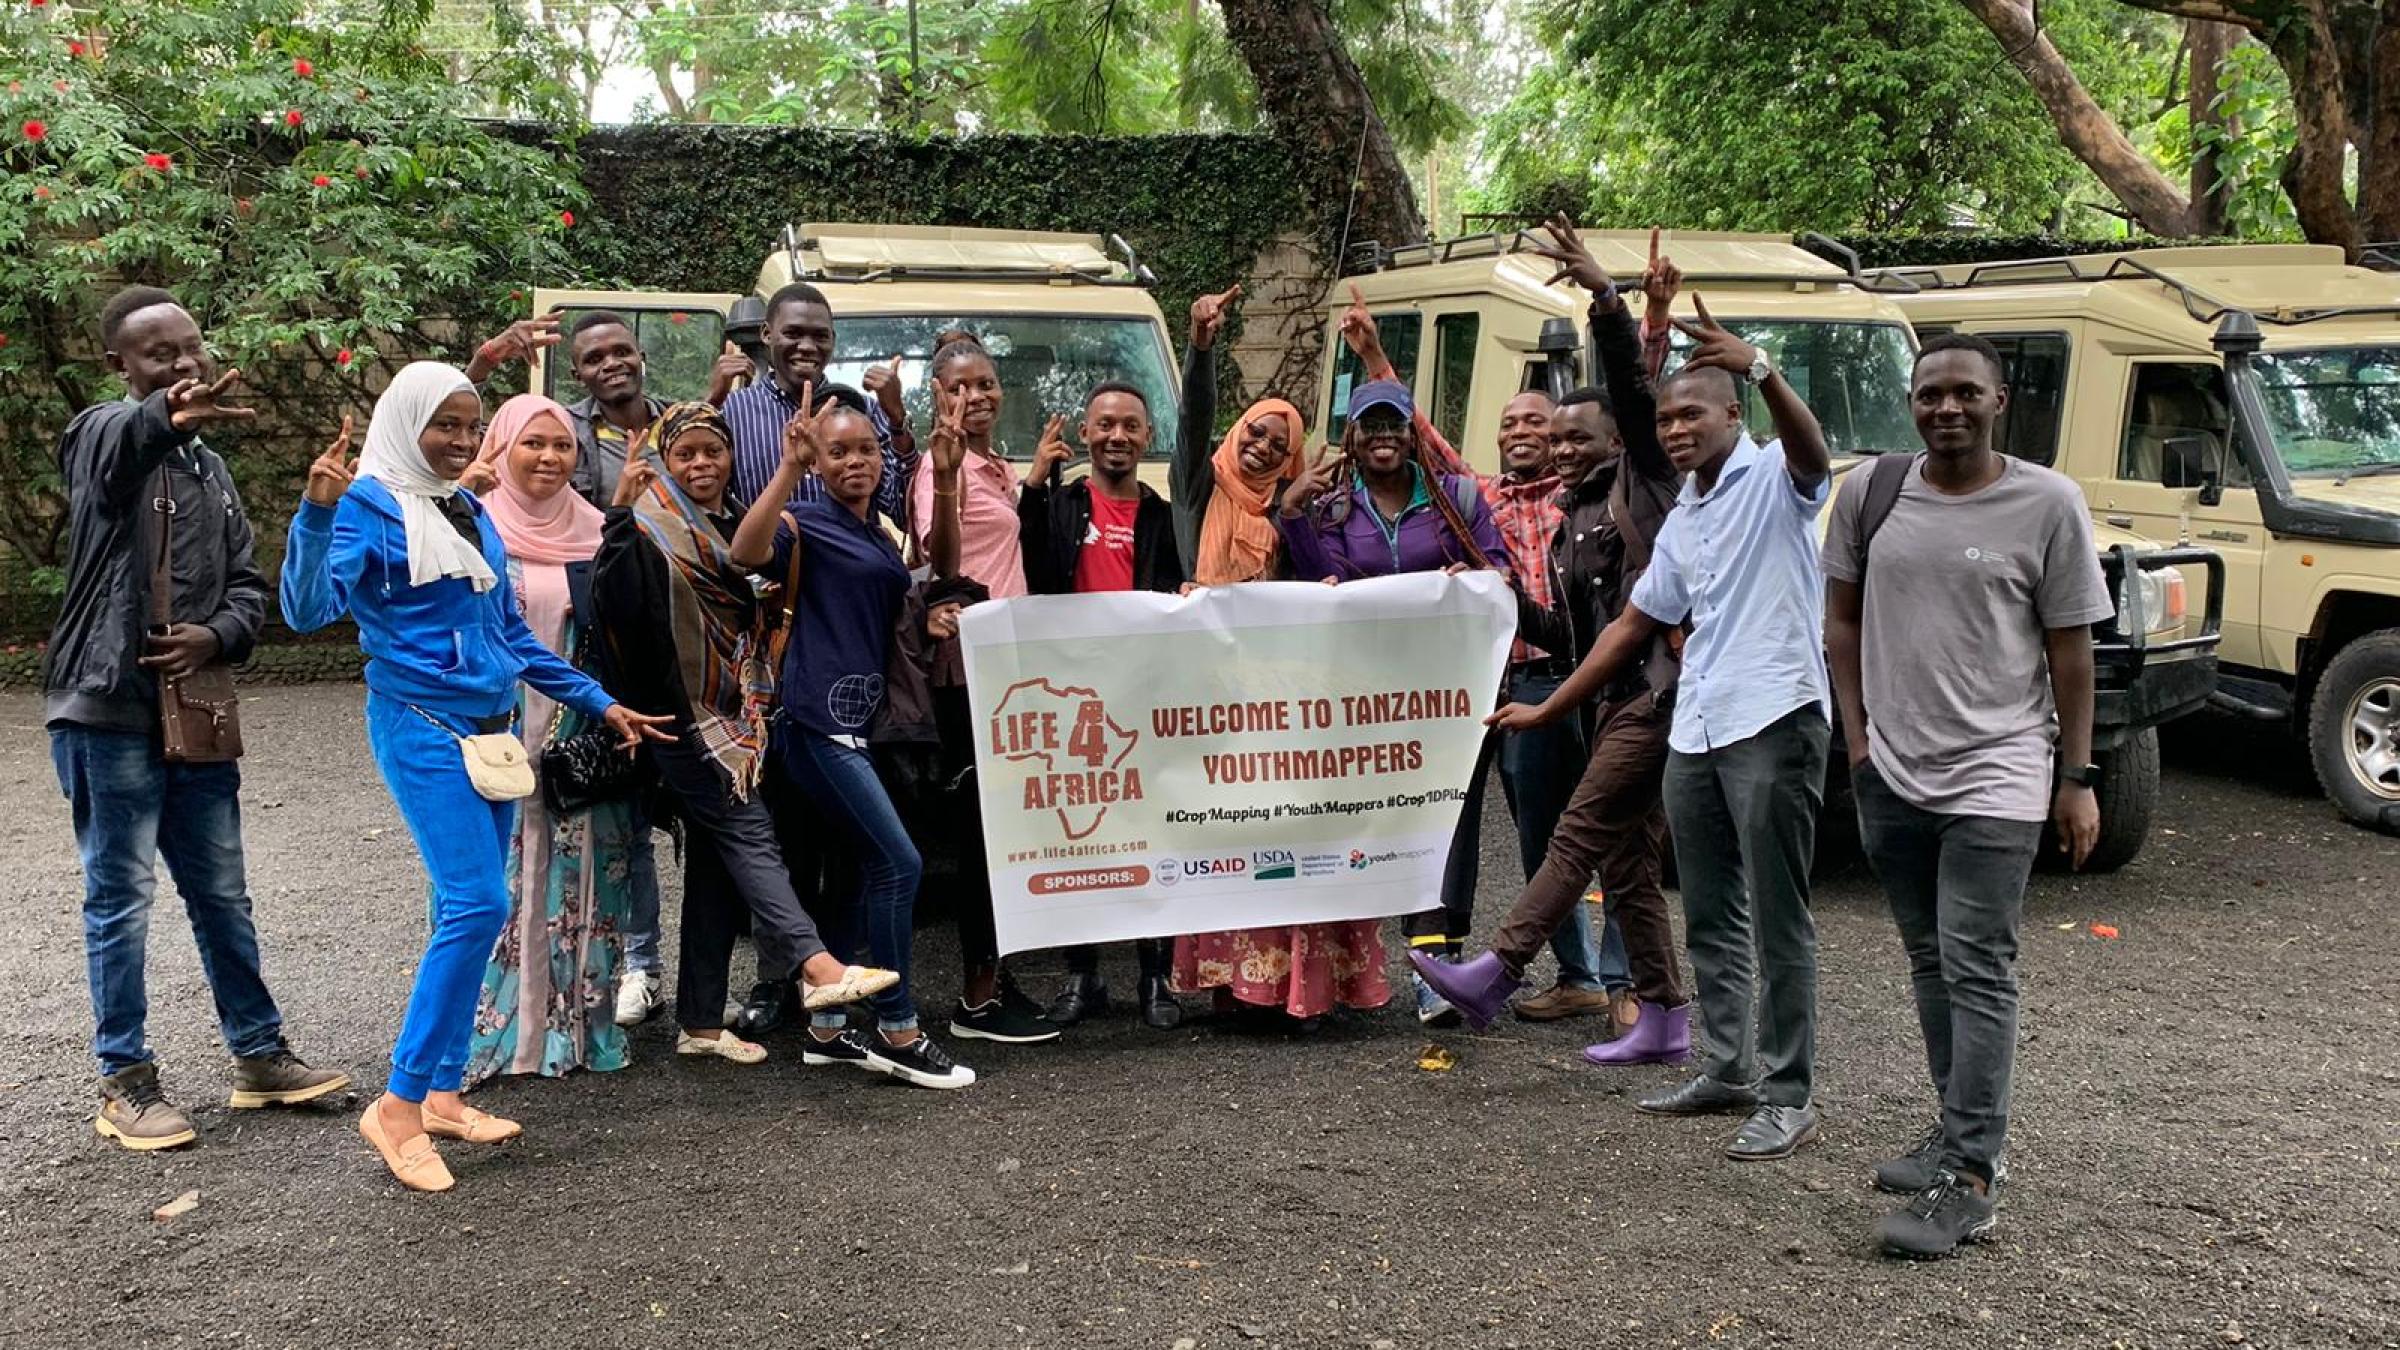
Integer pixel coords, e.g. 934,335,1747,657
1666,704,1831,1107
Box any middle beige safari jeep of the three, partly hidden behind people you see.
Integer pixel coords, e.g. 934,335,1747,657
1318,231,2222,870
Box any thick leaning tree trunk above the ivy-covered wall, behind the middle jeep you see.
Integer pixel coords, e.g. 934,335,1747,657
1217,0,1426,255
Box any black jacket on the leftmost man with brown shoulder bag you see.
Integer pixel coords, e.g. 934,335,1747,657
41,392,266,730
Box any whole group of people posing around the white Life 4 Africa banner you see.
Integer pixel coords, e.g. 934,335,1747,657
46,221,2110,1254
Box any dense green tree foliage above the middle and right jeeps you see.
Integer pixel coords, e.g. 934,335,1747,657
1483,0,2172,231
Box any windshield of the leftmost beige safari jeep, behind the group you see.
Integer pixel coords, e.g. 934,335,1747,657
826,312,1178,459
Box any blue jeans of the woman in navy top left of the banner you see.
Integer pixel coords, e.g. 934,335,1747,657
775,725,924,1031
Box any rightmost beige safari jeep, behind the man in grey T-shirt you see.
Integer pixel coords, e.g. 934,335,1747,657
1877,245,2400,831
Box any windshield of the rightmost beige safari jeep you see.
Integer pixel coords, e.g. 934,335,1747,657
2249,346,2400,476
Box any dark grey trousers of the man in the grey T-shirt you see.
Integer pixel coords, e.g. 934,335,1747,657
1850,764,2042,1182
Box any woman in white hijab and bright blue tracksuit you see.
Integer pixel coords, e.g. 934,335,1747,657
283,360,691,1191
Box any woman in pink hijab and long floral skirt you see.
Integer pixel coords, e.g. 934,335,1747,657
466,394,634,1086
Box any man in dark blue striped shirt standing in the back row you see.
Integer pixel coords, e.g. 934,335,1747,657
725,281,917,531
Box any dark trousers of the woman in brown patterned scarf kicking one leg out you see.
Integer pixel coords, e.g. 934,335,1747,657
650,733,826,1031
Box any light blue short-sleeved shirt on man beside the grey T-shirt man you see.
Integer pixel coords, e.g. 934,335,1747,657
1632,432,1831,754
